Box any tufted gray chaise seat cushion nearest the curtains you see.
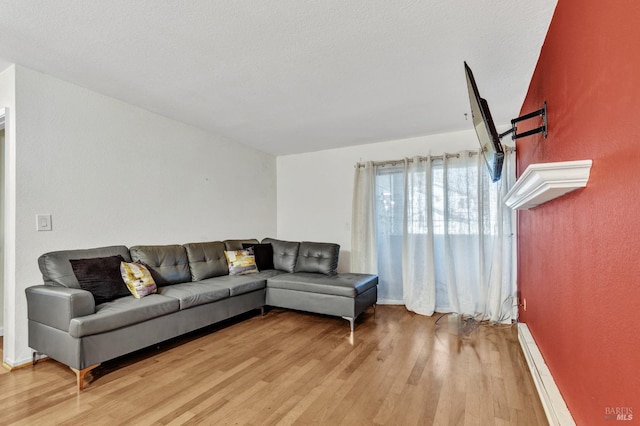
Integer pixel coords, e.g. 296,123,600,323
267,272,378,297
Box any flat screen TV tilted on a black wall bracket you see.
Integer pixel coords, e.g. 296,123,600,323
464,62,504,182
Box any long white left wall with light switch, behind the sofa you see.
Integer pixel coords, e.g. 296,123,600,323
5,66,276,365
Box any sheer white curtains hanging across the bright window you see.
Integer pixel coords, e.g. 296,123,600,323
352,152,516,322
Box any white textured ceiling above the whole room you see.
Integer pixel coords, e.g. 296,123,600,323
0,0,557,155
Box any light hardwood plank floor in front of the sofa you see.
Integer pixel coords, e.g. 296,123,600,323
0,305,547,426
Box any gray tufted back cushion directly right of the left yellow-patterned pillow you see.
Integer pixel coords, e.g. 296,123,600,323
129,244,191,286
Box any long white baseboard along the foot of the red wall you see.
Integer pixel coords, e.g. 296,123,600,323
518,323,575,426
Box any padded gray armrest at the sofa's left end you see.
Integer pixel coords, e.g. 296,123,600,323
25,285,96,332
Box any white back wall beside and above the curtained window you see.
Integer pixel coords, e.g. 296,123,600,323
277,130,479,272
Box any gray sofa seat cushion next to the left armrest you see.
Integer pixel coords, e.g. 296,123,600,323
69,294,180,337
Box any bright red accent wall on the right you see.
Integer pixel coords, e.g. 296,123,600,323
517,0,640,425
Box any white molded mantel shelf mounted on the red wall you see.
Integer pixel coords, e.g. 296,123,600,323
505,160,592,209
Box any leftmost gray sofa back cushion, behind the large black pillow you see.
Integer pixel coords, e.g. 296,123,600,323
38,246,131,288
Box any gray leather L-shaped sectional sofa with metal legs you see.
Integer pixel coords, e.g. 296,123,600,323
26,238,378,390
